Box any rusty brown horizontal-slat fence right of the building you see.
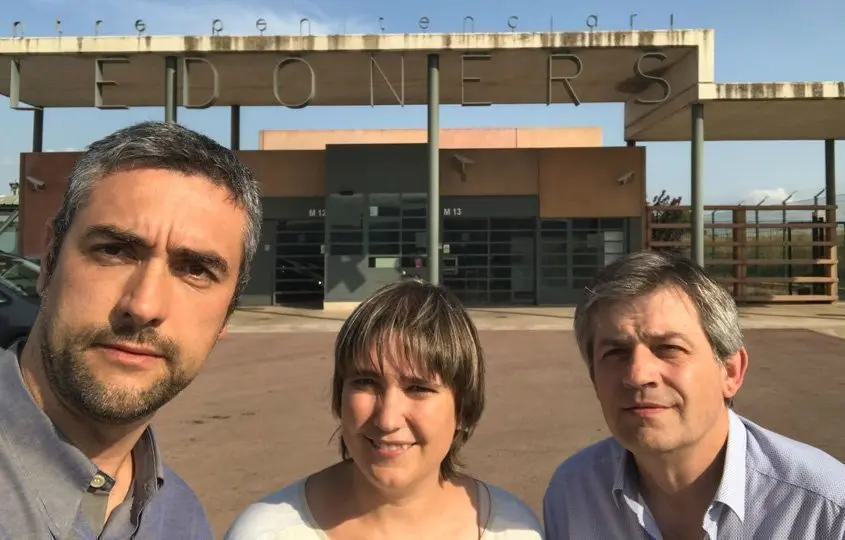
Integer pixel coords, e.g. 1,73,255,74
645,194,845,302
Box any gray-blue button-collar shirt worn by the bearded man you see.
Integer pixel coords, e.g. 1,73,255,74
0,349,213,540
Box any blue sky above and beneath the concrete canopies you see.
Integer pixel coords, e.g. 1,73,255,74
0,0,845,209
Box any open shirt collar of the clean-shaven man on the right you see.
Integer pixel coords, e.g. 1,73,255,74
612,409,748,521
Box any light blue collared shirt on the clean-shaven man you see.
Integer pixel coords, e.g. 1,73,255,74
543,411,845,540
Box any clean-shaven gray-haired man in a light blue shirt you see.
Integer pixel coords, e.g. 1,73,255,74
543,251,845,540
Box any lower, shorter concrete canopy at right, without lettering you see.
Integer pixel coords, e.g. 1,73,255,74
625,82,845,142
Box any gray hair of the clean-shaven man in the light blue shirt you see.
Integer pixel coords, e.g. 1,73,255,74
575,250,743,374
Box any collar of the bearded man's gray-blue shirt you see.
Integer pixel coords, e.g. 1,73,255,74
0,350,164,537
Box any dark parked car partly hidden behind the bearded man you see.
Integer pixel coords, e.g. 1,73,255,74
0,252,41,353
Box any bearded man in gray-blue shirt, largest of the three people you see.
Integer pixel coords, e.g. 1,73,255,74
0,122,261,540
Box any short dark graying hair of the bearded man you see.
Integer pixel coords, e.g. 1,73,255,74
43,122,262,314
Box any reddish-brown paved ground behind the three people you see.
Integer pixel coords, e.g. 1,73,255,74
156,330,845,535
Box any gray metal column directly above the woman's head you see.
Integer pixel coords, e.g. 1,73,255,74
426,54,440,285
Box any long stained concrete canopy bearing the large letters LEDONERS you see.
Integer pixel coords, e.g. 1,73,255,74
0,30,713,107
